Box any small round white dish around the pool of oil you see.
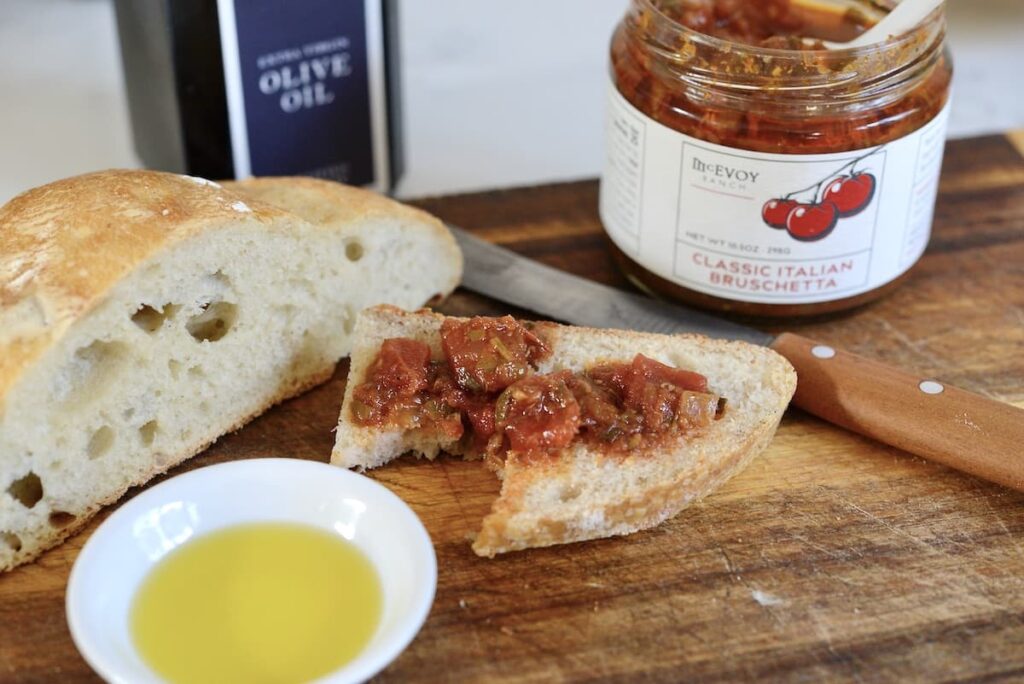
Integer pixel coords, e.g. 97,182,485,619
67,459,437,684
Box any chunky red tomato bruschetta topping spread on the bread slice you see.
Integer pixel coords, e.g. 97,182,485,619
351,316,725,463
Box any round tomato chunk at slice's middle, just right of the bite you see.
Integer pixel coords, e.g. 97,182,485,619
495,371,580,452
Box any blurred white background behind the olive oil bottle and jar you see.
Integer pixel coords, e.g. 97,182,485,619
0,0,1024,202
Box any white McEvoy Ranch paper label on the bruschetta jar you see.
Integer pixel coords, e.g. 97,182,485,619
600,80,949,304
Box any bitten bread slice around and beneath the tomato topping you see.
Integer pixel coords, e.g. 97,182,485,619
332,306,797,556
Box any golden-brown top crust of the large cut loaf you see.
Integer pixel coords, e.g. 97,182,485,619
0,170,299,411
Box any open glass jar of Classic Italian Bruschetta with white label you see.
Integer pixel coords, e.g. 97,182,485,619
600,0,952,316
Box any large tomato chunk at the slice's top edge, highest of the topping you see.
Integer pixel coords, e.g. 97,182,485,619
441,316,547,392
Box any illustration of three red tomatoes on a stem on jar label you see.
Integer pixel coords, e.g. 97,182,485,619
761,145,885,243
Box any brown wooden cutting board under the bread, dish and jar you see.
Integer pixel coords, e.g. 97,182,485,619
0,135,1024,682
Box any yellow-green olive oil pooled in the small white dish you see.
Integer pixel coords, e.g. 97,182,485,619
130,523,383,684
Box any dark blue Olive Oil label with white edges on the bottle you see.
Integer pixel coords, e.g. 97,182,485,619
218,0,387,187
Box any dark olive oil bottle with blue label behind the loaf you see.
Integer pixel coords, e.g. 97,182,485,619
115,0,401,191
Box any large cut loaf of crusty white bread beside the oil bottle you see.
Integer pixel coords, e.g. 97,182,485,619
0,171,462,570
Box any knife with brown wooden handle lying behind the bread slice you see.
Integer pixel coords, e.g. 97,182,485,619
449,225,1024,491
